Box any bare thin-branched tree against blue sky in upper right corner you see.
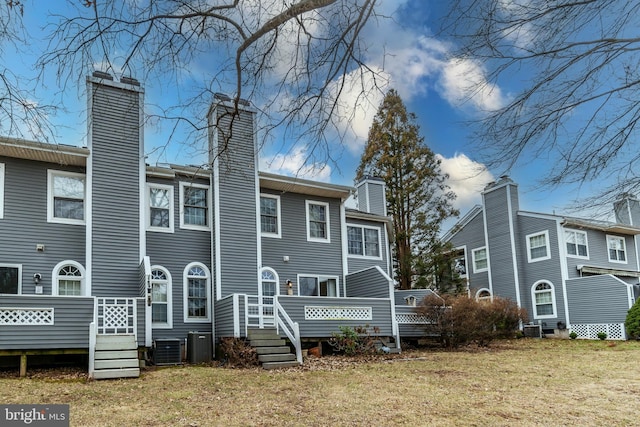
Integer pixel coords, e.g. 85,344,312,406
443,0,640,200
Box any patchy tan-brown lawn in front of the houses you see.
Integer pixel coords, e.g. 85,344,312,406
0,339,640,426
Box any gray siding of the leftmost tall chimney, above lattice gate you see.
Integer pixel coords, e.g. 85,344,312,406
90,83,143,297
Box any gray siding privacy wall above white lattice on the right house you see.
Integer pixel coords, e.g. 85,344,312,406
567,274,630,323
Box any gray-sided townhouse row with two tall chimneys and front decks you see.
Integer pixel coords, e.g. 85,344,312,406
0,74,411,377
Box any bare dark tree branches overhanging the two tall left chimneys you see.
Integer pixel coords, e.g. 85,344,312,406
39,0,378,166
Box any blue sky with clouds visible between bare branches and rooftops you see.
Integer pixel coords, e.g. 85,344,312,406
3,0,616,227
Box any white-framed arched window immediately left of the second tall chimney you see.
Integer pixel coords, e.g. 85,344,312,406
184,262,211,322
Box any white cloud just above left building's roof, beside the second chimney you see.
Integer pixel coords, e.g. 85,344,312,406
259,146,331,182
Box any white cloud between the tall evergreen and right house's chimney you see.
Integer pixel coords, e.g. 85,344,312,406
436,153,495,215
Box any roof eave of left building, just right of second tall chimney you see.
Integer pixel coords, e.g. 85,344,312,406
258,171,355,200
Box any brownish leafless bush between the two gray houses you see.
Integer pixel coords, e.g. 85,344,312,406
416,295,528,348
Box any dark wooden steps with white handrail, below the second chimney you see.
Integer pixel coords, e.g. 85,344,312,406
247,328,300,369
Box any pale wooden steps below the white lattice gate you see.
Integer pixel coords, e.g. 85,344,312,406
93,335,140,380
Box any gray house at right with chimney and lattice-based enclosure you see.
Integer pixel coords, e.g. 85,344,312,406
444,177,640,339
